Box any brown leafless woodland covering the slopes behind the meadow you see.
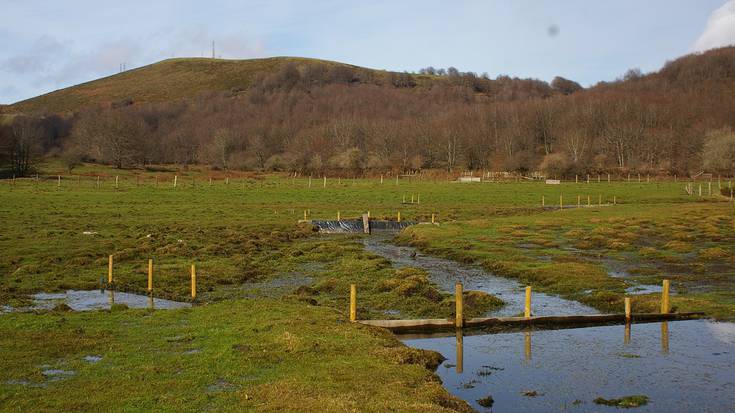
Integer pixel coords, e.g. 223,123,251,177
0,48,735,176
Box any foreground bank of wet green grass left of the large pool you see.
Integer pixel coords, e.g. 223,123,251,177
0,300,471,412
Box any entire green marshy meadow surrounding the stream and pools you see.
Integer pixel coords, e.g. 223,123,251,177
0,163,735,411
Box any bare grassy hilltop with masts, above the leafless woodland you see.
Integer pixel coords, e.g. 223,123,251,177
4,57,420,113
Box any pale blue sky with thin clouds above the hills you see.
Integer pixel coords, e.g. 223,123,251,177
0,0,735,103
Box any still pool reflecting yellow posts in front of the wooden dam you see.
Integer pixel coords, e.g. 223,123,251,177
404,320,735,412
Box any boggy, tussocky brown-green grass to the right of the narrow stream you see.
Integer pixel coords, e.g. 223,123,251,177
400,203,735,320
